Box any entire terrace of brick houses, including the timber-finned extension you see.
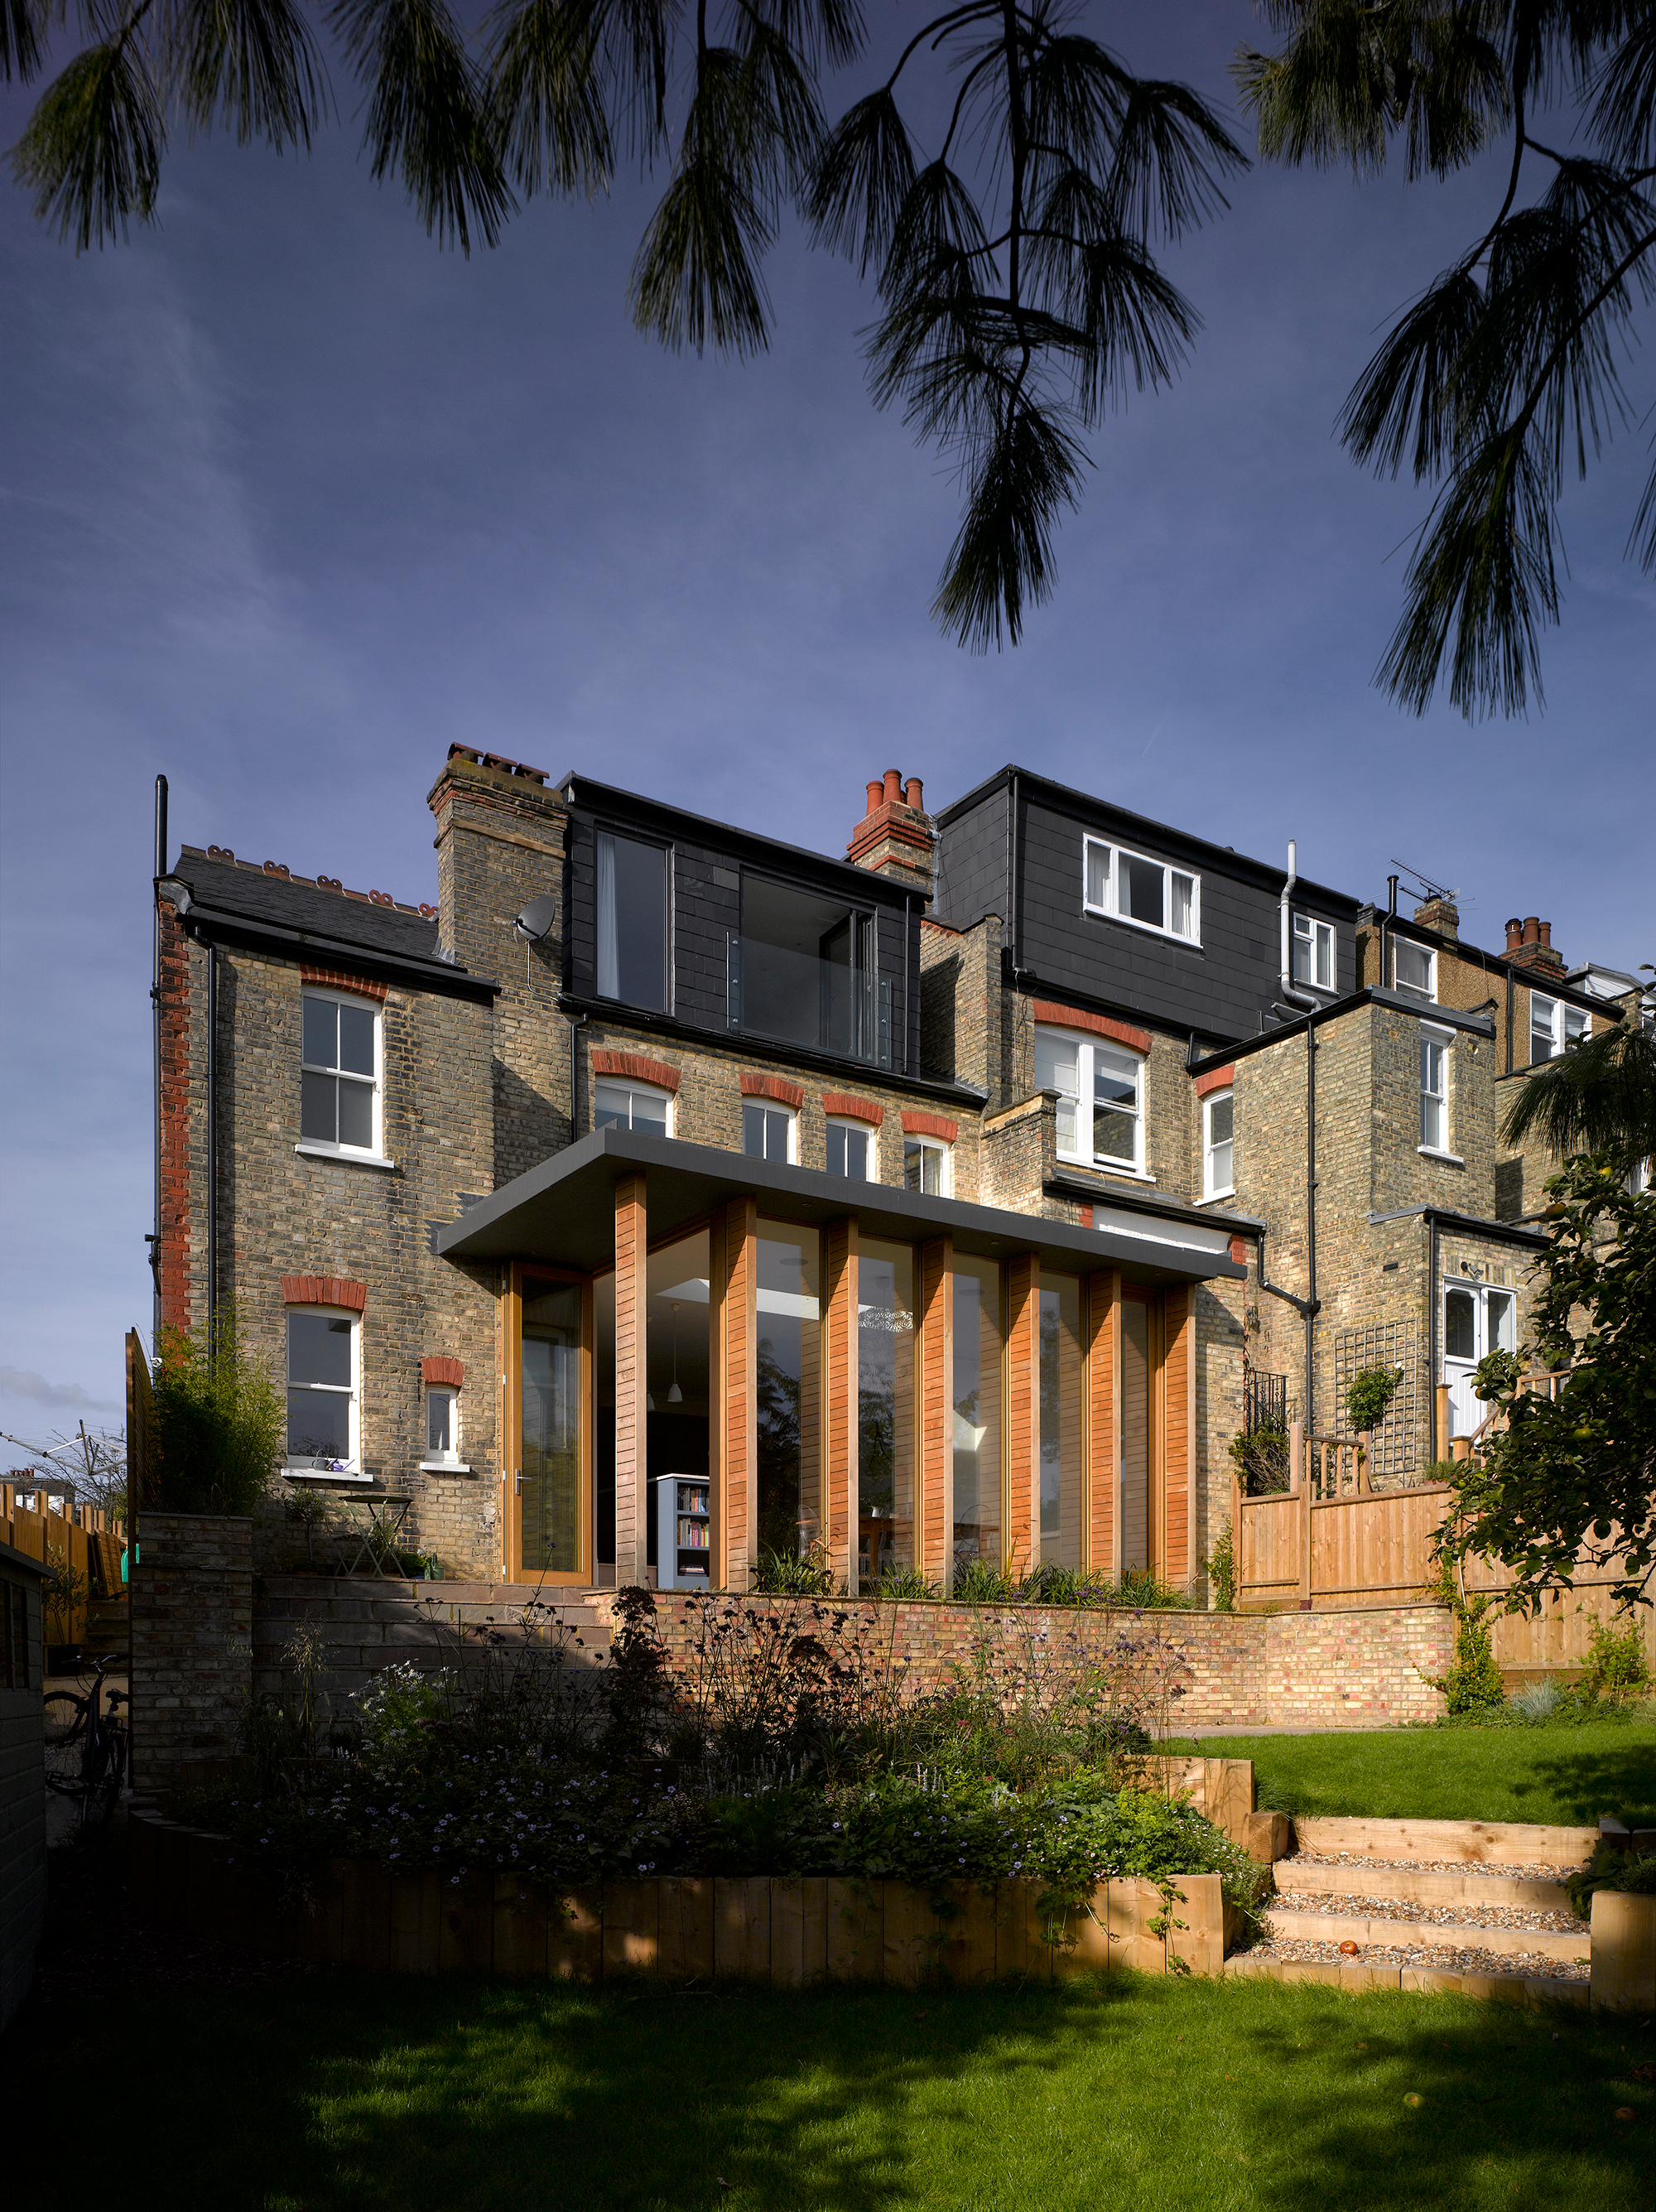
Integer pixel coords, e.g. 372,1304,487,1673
155,745,1635,1590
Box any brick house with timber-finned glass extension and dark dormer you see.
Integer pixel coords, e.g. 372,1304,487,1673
155,748,1243,1588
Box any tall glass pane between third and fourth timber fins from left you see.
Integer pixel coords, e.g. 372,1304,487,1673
858,1243,915,1588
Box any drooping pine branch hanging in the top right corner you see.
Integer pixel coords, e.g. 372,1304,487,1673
1236,0,1656,716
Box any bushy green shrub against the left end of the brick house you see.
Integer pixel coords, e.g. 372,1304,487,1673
144,1305,287,1513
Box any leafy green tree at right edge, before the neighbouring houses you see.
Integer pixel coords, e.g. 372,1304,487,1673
1444,1159,1656,1608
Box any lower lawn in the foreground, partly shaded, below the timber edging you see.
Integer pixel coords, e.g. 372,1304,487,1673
0,1973,1656,2212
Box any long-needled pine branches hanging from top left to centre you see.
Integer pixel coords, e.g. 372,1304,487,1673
0,0,1244,646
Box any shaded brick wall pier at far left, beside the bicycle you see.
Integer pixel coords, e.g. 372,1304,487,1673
131,1511,252,1792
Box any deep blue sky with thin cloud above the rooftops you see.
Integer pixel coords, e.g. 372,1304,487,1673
0,0,1656,1464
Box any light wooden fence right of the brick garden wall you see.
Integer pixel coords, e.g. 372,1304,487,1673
1231,1422,1656,1672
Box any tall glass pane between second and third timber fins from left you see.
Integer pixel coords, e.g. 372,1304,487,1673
758,1221,822,1557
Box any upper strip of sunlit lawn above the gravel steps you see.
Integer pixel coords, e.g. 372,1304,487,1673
1176,1721,1656,1827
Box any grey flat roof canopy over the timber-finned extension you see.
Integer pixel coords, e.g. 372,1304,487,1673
436,1128,1247,1285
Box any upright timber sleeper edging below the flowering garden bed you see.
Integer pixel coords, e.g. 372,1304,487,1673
128,1812,1227,1988
